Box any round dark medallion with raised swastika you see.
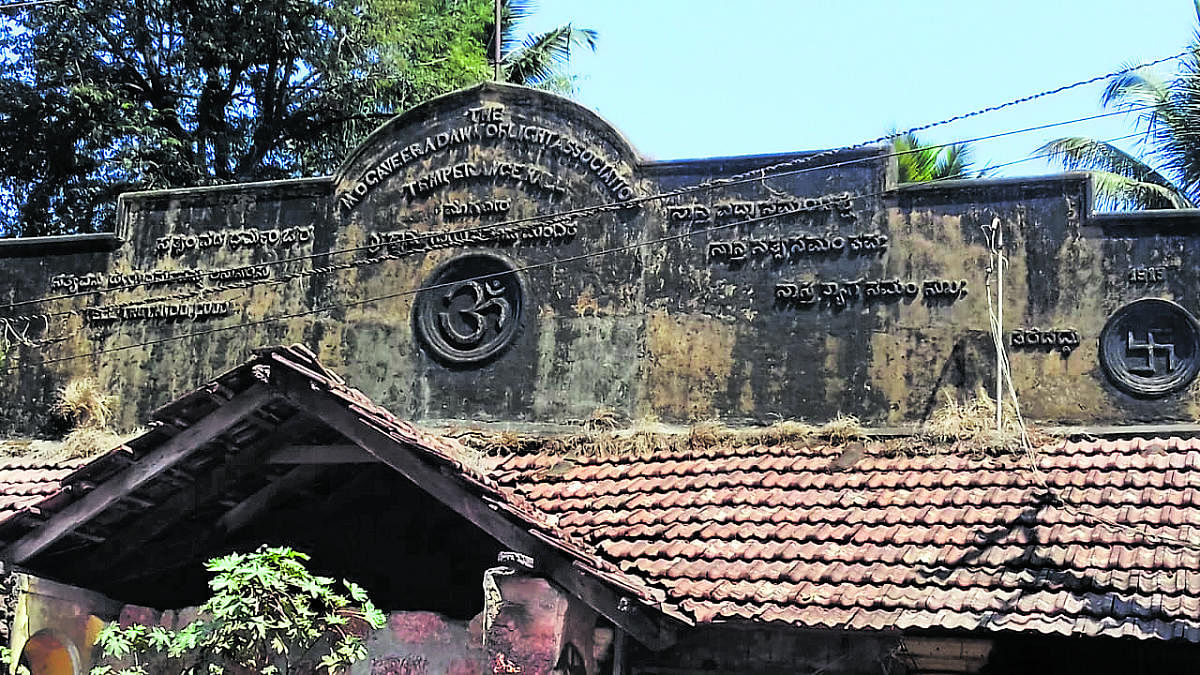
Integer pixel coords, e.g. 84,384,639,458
1100,298,1200,399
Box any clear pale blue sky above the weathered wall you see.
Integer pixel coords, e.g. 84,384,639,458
526,0,1196,175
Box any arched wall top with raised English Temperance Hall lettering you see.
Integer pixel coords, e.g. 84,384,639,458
334,83,641,216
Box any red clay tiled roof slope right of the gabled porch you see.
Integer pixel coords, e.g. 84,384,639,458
494,438,1200,643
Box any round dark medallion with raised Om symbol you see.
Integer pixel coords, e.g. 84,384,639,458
413,253,524,365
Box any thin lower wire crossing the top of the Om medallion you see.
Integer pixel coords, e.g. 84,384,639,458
0,133,1139,372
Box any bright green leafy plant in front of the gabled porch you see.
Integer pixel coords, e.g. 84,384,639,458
91,546,384,675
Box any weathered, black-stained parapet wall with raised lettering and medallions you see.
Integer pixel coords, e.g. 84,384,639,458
0,84,1200,434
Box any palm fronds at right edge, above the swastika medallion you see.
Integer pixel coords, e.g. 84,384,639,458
1037,0,1200,209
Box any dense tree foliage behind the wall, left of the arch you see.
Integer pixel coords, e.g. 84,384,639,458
0,0,492,235
